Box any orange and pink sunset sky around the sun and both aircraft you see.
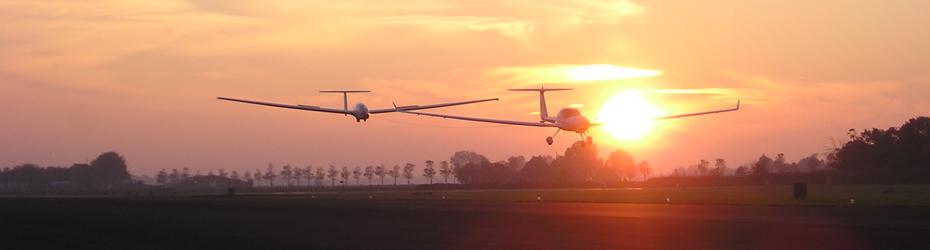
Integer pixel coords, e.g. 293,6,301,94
0,0,930,175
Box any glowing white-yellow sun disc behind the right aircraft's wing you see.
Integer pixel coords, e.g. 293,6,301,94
597,90,665,141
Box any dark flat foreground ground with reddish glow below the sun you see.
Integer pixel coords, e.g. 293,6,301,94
0,197,930,249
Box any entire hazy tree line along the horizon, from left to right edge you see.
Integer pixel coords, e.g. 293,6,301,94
0,117,930,189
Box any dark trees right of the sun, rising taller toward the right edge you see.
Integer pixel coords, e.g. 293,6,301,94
651,117,930,184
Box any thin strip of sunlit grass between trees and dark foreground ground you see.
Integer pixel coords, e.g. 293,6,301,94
239,185,930,206
